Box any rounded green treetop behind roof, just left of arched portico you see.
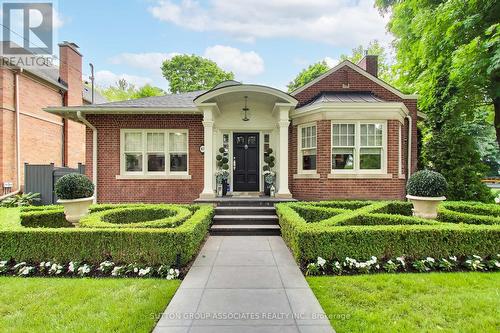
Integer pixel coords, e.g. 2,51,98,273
161,54,234,93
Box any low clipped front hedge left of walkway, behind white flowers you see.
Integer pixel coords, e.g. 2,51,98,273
0,205,213,267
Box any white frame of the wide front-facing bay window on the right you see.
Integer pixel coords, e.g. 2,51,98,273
328,120,388,178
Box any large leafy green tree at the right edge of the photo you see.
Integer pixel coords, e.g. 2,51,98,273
376,0,500,201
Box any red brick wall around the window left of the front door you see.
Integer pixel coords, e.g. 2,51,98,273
86,115,203,203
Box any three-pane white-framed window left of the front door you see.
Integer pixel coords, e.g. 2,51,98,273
120,129,188,176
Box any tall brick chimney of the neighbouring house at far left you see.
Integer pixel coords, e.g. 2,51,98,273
59,41,83,106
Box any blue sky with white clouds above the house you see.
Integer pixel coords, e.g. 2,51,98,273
51,0,391,90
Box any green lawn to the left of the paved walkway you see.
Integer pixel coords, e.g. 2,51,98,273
0,277,180,333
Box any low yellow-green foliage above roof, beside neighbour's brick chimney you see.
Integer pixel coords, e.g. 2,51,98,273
99,79,165,102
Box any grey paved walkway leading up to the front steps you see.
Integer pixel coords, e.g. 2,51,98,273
154,236,334,333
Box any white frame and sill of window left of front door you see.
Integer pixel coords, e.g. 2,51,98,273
116,128,191,179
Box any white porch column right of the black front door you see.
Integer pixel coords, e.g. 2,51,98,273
276,107,292,198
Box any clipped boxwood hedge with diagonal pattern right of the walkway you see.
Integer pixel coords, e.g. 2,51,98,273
276,198,500,266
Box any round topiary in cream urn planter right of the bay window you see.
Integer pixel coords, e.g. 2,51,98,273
406,170,448,219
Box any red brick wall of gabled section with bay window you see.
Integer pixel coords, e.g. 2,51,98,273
289,66,417,200
